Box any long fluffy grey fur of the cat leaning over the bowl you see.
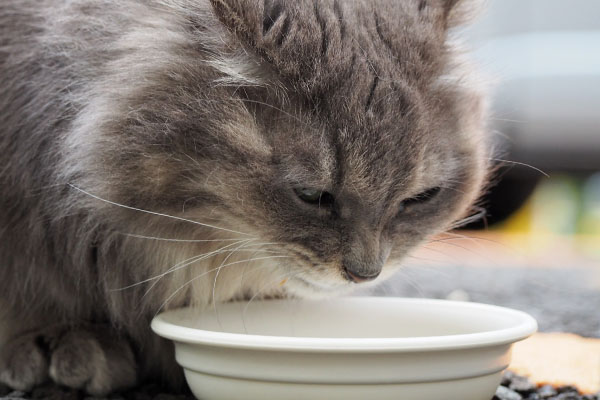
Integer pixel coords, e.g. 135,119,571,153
0,0,488,394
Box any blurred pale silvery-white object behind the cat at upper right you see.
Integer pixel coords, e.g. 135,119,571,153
464,0,600,166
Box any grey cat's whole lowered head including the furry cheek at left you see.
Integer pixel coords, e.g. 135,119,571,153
81,0,488,295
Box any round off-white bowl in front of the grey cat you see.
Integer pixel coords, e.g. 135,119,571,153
152,297,537,400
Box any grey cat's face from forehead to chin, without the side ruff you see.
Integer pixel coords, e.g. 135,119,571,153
176,0,487,295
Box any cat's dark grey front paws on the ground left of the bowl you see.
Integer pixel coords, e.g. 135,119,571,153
0,325,137,396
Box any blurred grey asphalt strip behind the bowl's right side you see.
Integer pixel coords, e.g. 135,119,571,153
375,266,600,338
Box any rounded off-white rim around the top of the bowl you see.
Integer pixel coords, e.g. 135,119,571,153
151,297,537,353
